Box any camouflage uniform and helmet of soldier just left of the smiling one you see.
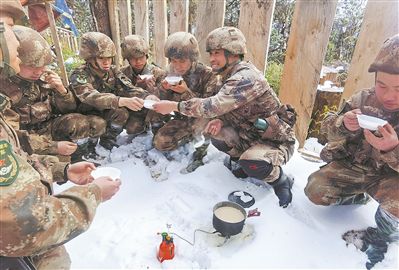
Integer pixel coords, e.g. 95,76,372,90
154,32,221,151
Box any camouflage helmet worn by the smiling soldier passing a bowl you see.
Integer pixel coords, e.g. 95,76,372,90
206,27,247,54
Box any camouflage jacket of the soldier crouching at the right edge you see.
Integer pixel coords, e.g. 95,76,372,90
320,88,399,172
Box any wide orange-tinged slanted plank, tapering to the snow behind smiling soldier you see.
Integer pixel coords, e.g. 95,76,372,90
279,0,337,147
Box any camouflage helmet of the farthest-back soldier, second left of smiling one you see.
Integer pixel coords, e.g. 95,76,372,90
121,35,150,59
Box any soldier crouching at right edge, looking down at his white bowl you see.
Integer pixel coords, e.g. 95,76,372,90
305,35,399,269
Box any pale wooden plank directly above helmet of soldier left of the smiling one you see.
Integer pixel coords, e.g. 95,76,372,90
169,0,189,34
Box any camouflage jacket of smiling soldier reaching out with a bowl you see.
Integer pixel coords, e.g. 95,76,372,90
179,62,295,145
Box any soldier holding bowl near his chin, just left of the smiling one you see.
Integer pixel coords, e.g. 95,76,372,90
154,32,221,170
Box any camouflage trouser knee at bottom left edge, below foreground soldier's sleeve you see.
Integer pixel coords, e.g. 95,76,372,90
32,246,71,270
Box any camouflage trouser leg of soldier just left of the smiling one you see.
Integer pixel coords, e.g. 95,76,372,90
153,117,209,151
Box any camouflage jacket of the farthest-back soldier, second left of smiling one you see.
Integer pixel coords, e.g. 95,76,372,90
121,64,166,97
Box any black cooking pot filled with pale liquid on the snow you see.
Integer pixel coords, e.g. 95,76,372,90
212,201,260,237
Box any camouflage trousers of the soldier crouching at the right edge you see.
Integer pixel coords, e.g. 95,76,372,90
305,161,399,218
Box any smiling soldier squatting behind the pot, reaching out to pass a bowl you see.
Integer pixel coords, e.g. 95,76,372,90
154,27,295,207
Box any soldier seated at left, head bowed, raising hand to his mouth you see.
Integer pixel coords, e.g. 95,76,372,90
0,26,106,160
